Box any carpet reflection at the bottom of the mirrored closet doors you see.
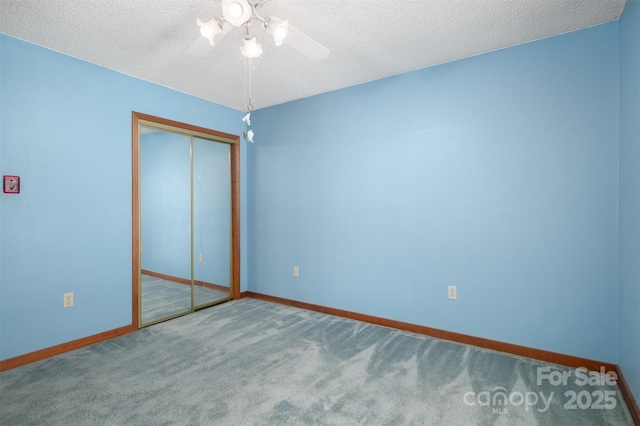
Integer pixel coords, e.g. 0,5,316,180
140,274,229,325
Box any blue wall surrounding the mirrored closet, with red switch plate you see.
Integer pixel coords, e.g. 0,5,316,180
0,35,246,359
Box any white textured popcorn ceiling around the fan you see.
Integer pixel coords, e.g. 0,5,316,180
0,0,625,110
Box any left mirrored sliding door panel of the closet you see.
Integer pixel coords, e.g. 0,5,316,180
140,126,191,325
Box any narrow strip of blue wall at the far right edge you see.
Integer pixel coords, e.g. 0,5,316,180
619,0,640,402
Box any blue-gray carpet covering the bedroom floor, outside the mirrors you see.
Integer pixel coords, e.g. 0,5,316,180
0,298,631,426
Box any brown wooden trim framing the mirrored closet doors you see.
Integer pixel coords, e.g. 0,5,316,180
131,111,240,330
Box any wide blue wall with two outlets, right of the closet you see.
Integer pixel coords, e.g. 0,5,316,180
248,23,619,362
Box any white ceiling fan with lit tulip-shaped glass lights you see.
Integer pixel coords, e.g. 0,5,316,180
187,0,329,61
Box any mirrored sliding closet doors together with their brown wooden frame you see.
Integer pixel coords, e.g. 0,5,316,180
132,112,240,328
